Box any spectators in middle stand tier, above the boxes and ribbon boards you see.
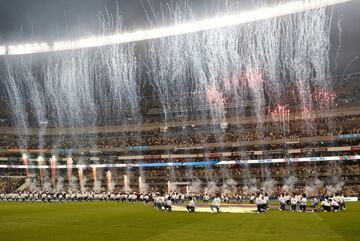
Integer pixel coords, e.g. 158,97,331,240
0,115,360,152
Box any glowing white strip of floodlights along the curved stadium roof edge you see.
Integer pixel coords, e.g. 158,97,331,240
0,0,352,55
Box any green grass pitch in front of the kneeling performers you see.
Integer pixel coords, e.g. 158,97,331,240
0,202,360,241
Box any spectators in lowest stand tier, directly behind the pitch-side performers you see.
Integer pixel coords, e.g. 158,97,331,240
0,160,360,196
